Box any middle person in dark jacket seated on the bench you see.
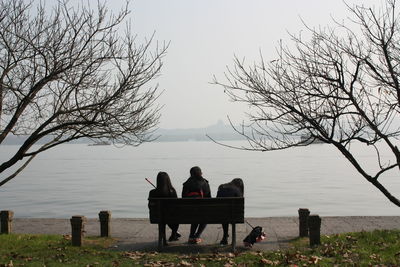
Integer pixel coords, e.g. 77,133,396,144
182,166,211,244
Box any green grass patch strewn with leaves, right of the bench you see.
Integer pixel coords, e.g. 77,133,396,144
285,230,400,266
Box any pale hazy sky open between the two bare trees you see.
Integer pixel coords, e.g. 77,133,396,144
87,0,381,128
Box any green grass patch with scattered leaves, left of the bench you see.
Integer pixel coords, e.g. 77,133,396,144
0,234,130,267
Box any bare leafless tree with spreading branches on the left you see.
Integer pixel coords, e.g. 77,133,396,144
0,0,168,186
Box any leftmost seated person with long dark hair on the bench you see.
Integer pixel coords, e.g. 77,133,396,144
149,172,181,244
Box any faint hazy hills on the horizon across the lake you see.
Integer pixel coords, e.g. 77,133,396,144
3,120,245,145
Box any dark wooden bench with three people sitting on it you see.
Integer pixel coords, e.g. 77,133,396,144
149,197,244,251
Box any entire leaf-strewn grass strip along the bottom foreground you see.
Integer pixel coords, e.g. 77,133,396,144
0,230,400,267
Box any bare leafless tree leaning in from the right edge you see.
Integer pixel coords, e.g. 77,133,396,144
214,0,400,206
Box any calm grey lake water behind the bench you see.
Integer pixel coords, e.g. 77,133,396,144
0,141,400,218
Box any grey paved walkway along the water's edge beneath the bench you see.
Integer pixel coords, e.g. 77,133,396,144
13,216,400,253
